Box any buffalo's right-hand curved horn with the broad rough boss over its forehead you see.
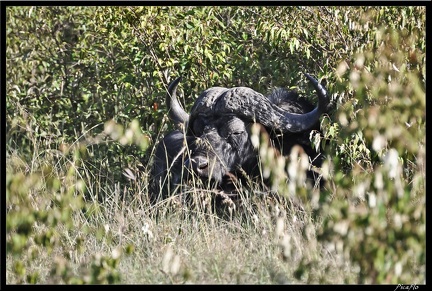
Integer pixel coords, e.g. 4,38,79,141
190,74,329,132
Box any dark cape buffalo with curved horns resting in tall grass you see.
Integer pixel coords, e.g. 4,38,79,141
150,74,329,202
